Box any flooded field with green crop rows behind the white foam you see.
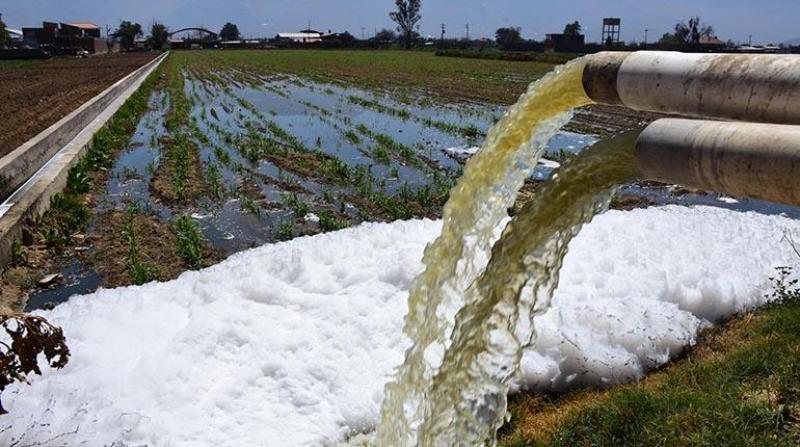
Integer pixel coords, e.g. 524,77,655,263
7,52,797,309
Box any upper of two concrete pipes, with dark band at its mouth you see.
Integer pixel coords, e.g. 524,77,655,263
583,51,800,124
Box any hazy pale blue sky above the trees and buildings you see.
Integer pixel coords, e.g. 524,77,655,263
0,0,800,44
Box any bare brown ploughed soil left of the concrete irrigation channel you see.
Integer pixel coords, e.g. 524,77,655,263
0,53,157,156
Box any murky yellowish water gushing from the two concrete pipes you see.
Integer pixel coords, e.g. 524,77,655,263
376,55,635,447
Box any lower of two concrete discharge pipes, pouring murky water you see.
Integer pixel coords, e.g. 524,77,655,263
636,118,800,206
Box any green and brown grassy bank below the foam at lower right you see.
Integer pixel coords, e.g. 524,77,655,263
501,272,800,447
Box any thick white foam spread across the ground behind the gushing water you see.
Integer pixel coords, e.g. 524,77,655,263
0,206,800,446
